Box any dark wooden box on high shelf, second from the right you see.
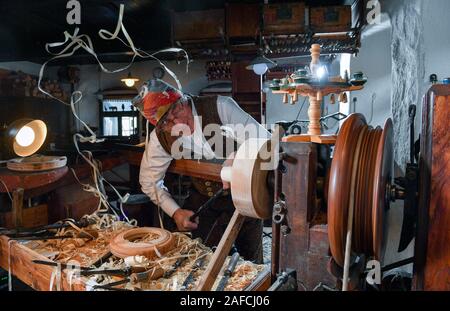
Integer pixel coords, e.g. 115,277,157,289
263,2,305,34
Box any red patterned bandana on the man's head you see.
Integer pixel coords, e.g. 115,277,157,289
133,80,182,125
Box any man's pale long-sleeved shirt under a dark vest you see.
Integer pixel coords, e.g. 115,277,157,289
139,96,270,217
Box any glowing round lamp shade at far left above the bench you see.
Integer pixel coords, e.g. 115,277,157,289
6,119,47,157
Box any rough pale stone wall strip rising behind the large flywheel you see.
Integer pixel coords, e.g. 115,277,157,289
388,0,425,169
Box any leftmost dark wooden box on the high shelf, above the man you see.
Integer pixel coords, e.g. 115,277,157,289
172,9,225,41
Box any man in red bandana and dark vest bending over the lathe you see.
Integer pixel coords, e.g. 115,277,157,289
133,79,270,263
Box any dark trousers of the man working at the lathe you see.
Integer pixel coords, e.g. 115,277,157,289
161,189,263,264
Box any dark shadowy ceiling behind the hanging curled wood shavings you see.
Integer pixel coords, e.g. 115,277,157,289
0,0,354,64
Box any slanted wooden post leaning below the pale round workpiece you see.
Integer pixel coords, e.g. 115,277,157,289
197,210,245,291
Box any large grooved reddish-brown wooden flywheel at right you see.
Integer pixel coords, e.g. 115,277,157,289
328,114,393,267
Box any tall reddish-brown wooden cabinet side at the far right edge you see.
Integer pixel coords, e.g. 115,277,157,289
414,85,450,291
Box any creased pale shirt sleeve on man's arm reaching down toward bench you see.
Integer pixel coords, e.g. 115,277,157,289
139,131,180,217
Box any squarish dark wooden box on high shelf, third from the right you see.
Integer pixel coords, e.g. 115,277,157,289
226,3,261,38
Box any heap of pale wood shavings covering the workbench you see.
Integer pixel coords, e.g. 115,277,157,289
11,214,265,291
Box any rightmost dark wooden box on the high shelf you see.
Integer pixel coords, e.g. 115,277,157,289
309,5,352,32
